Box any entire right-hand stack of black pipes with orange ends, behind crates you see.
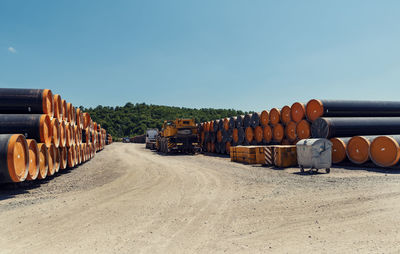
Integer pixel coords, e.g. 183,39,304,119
199,99,400,167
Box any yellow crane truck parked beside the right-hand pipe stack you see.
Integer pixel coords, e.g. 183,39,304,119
156,119,200,154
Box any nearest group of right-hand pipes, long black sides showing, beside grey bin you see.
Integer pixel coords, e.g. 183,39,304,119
307,99,400,167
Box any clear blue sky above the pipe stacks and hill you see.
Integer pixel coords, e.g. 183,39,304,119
0,0,400,110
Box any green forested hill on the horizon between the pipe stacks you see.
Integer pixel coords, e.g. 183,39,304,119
83,102,245,137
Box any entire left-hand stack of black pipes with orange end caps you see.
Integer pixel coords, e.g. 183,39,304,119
0,88,112,183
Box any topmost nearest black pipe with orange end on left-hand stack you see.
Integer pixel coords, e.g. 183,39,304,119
0,88,54,117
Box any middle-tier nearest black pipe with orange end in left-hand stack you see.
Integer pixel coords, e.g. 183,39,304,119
0,114,53,147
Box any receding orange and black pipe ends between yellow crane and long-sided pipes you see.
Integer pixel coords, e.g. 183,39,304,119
199,102,311,154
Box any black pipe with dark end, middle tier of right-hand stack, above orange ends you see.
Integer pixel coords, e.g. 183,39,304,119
311,117,400,138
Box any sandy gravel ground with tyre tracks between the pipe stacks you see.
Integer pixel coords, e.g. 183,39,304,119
0,143,400,253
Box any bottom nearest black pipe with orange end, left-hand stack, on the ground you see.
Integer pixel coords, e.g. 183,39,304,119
0,134,29,183
